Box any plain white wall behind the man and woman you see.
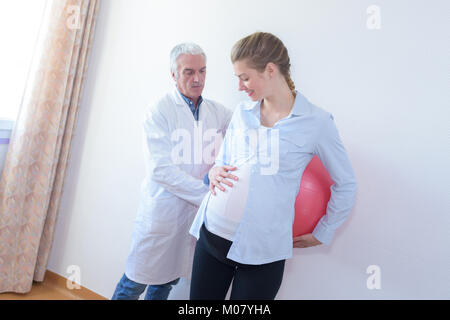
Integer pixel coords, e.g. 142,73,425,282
49,0,450,299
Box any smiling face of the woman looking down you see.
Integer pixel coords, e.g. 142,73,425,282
233,60,268,101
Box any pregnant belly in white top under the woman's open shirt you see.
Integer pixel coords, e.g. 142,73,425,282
207,164,250,222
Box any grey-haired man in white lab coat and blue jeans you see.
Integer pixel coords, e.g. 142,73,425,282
112,43,231,300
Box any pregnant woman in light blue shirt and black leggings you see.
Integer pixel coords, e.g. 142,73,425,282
190,32,356,300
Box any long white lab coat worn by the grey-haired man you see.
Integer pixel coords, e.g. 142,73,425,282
125,89,232,285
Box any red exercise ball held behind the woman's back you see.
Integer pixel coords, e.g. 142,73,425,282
292,156,333,237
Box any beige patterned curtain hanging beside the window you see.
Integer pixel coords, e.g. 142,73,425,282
0,0,100,293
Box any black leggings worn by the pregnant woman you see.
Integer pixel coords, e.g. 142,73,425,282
190,225,285,300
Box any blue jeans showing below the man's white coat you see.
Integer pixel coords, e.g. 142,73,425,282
111,274,180,300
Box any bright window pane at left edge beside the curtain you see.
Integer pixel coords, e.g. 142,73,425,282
0,0,46,120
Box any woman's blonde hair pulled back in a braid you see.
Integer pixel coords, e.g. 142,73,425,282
231,32,296,96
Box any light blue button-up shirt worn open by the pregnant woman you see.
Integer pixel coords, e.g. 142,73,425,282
190,91,357,265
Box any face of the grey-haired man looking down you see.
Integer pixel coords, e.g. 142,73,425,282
172,54,206,100
